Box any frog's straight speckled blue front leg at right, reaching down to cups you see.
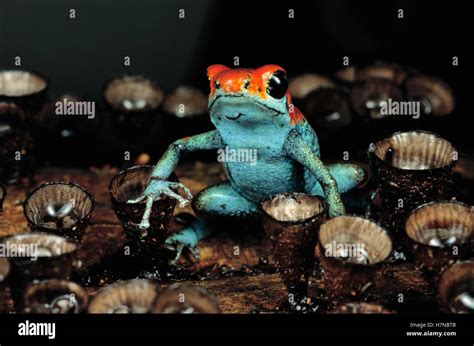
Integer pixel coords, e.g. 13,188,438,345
283,131,345,217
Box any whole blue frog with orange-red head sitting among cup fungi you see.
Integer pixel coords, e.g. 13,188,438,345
129,65,365,257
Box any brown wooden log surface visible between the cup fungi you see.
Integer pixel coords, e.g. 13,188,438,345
0,162,436,313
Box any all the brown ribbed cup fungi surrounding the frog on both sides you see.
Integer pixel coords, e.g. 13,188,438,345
0,63,474,313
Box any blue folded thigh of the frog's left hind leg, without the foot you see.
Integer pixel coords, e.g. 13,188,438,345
193,182,258,217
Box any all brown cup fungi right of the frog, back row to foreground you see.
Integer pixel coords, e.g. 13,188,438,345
268,62,474,313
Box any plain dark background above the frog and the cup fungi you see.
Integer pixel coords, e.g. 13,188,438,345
0,0,473,163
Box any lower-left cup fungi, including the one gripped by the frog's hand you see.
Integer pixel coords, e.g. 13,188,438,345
0,174,219,313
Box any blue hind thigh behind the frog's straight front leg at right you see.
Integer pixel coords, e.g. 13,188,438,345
311,163,366,196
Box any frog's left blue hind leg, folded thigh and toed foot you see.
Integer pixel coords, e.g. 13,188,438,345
166,182,259,259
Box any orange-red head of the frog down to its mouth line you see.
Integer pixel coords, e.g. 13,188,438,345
207,65,304,125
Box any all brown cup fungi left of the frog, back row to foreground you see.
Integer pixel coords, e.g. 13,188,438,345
0,71,219,313
